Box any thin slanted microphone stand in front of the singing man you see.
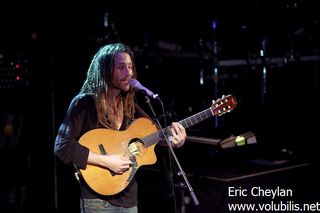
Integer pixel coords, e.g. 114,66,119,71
145,95,199,210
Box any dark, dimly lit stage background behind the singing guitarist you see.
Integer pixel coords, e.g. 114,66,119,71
0,0,320,212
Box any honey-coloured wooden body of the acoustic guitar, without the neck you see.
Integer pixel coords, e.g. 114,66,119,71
79,118,157,195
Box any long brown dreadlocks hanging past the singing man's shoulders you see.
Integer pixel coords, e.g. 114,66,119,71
80,43,137,129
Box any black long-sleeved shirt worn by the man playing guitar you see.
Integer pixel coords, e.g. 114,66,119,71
55,94,141,207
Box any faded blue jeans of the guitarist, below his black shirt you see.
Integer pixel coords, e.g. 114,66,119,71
80,198,138,213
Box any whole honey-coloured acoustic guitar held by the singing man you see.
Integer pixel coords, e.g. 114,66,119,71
79,95,237,195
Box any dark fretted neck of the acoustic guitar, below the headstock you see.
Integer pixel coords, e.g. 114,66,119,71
141,108,214,147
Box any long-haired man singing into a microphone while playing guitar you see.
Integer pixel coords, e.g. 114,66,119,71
55,43,186,213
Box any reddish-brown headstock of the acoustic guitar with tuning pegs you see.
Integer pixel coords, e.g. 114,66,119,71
211,95,237,116
